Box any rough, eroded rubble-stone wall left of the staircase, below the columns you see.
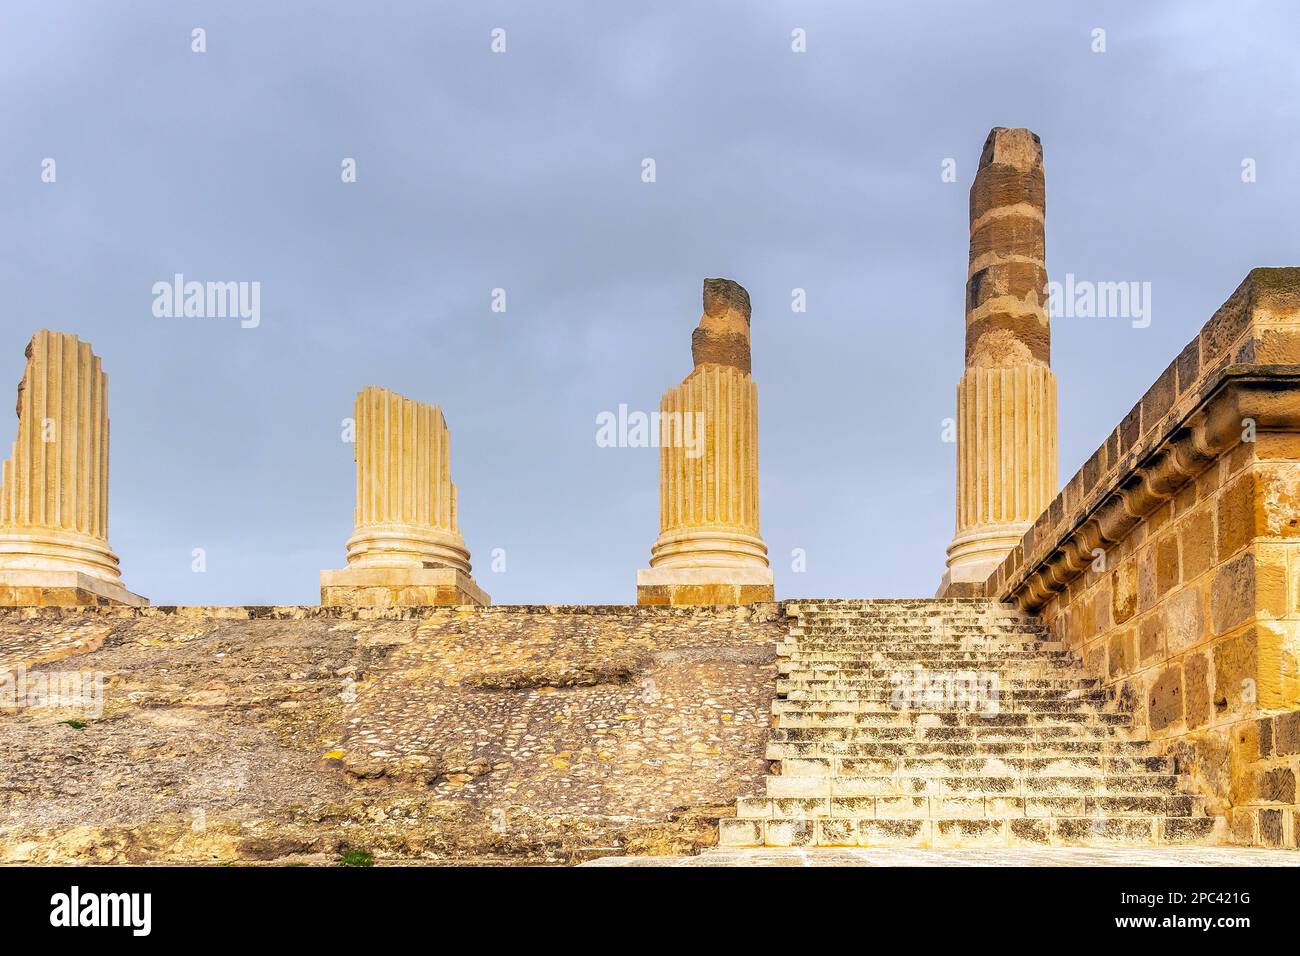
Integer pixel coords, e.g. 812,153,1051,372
0,605,787,862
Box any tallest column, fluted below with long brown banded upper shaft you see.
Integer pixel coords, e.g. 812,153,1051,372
940,127,1057,596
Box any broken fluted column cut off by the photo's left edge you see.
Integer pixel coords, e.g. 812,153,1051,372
0,329,148,606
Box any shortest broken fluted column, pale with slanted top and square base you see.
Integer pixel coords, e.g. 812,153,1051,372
321,386,491,606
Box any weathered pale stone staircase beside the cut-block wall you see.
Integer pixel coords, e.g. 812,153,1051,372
719,600,1226,847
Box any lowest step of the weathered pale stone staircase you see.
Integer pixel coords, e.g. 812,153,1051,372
719,817,1225,847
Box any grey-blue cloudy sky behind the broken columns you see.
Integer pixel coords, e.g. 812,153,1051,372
0,0,1300,604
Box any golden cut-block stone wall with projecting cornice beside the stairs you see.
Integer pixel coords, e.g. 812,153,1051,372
985,269,1300,847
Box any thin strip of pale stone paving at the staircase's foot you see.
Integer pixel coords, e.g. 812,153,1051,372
582,847,1300,866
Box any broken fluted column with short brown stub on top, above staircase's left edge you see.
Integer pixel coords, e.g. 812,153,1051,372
637,278,774,605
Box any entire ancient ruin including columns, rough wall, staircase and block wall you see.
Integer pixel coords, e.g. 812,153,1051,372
0,129,1300,865
